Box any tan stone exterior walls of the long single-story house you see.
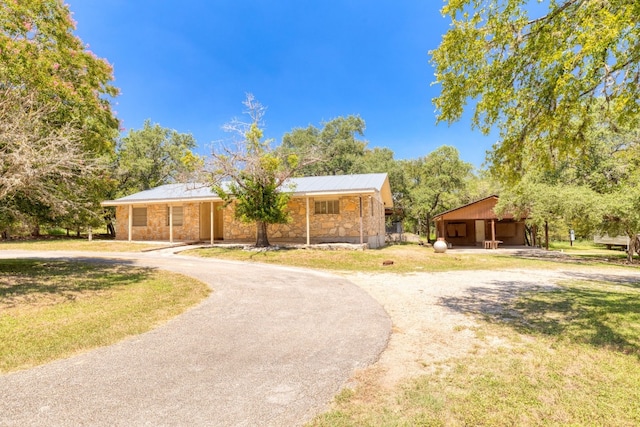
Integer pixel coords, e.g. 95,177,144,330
116,195,385,248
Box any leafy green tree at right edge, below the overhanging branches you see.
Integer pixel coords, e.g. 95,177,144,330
498,103,640,261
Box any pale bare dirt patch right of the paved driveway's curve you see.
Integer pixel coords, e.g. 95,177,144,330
347,270,640,388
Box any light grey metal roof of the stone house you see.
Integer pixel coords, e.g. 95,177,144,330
102,173,393,206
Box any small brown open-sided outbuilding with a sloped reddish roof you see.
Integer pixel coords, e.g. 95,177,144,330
433,195,526,249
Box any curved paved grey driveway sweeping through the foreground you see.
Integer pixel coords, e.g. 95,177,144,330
0,251,391,426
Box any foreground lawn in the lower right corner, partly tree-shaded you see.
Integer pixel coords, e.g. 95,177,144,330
310,280,640,426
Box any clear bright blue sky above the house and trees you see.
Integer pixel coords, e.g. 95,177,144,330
67,0,496,167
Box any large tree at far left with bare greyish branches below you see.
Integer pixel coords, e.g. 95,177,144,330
0,0,118,234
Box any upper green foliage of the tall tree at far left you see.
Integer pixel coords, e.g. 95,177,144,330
0,0,118,154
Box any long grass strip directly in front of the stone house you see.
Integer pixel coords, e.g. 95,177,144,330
182,244,632,273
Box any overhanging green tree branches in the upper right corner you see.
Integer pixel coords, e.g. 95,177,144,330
431,0,640,182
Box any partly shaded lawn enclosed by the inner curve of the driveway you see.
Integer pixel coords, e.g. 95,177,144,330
0,260,209,373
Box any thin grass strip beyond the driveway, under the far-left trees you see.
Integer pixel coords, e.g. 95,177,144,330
0,237,158,252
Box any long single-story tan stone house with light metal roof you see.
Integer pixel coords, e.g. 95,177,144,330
102,173,393,248
